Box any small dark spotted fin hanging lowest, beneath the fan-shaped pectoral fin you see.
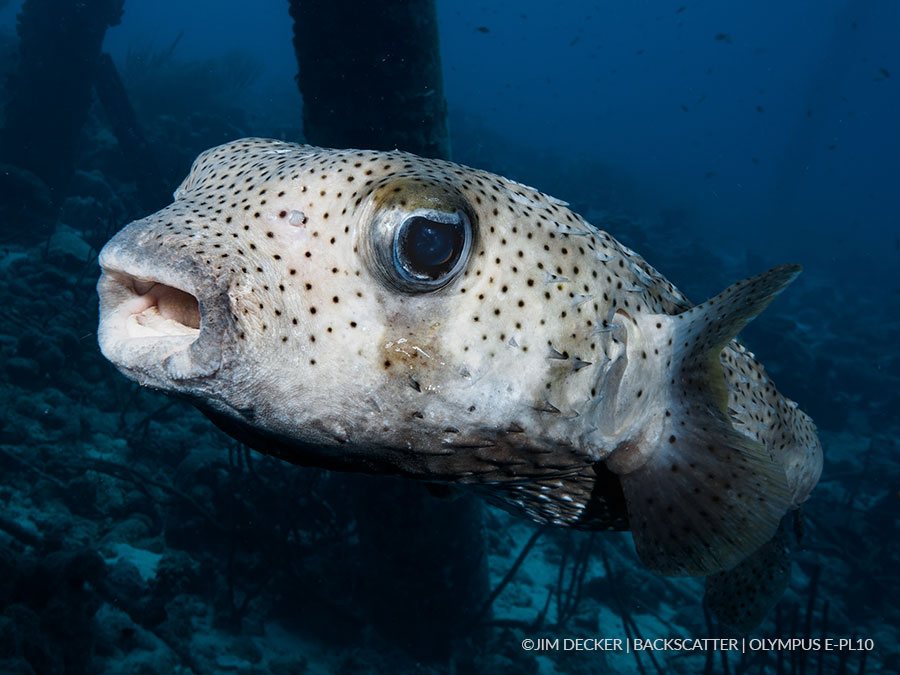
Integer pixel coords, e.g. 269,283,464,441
705,515,792,633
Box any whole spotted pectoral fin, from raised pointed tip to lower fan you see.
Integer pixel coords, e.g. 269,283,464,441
607,265,800,576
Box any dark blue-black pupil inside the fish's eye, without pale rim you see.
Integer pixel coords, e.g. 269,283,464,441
400,216,463,279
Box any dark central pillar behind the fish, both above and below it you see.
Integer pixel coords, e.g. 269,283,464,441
290,0,488,656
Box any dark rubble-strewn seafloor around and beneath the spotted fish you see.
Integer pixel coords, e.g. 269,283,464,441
0,45,900,674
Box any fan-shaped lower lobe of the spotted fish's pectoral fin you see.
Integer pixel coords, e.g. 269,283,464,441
619,419,790,576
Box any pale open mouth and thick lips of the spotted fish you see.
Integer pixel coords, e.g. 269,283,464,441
97,242,231,393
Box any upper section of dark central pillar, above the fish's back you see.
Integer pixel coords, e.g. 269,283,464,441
290,0,450,158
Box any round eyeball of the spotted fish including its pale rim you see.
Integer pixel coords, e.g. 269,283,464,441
393,210,471,290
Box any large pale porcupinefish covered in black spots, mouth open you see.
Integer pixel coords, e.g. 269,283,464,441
98,139,822,596
